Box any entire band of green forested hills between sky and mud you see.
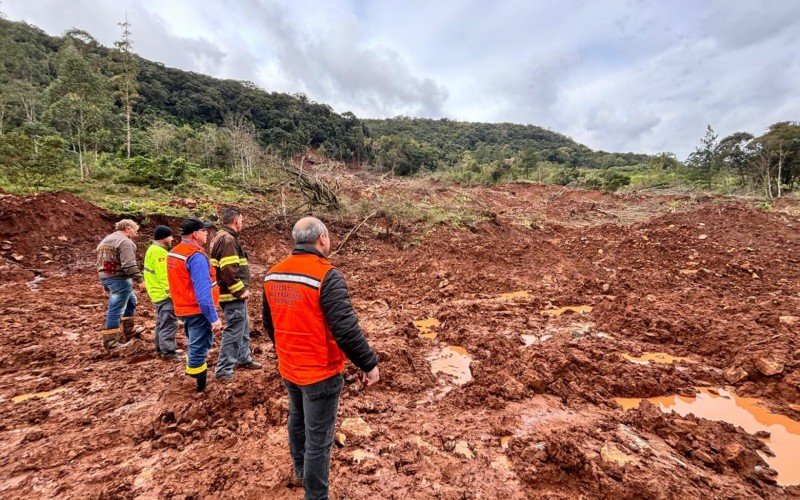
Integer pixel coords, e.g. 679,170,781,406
0,14,800,197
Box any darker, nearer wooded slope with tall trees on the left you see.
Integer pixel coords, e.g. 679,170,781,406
0,19,367,185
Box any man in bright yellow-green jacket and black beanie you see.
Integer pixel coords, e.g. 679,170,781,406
144,226,183,361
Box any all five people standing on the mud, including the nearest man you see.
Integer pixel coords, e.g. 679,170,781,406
97,207,380,498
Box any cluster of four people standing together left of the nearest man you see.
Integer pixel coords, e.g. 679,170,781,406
97,207,261,382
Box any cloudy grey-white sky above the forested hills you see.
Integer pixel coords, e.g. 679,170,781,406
0,0,800,158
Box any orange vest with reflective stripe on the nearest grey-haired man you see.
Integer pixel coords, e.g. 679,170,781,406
264,254,345,385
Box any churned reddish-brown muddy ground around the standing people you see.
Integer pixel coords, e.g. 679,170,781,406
0,185,800,498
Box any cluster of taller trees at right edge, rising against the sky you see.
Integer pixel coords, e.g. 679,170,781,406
680,121,800,198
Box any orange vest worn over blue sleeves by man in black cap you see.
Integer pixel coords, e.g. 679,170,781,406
167,243,219,316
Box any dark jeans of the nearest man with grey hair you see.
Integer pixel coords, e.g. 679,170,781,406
283,375,344,500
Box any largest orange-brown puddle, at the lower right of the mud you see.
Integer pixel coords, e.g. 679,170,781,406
615,389,800,486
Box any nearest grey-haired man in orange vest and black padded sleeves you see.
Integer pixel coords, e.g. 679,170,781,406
262,217,380,499
